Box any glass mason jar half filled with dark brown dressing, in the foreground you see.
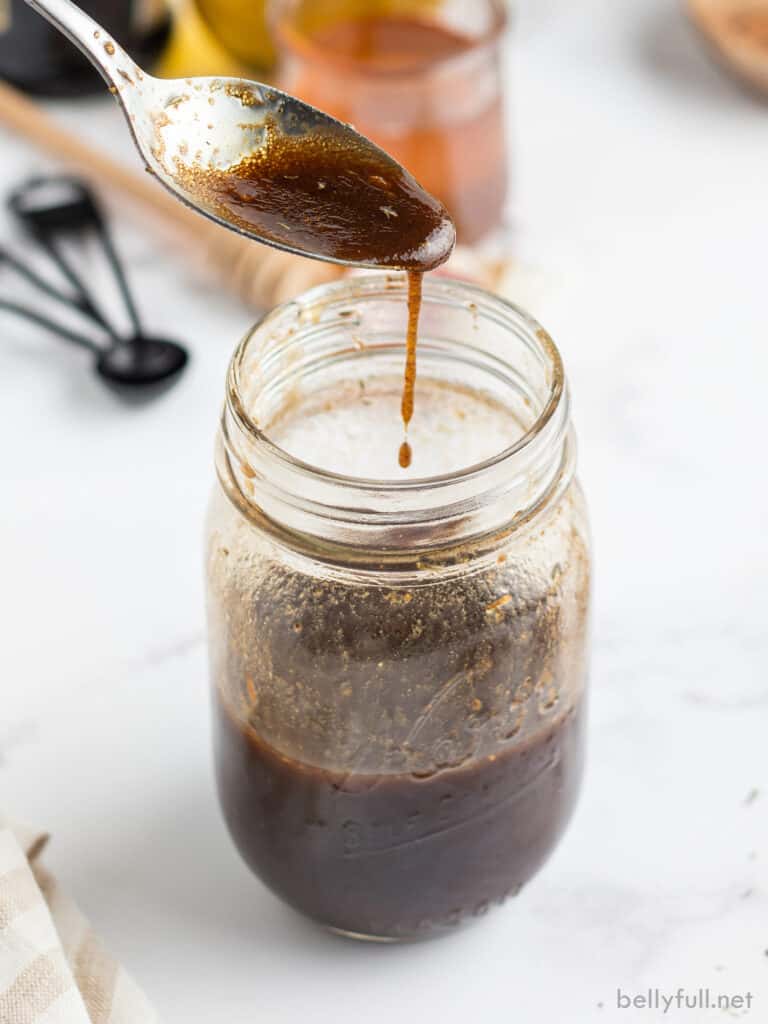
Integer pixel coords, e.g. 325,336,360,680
207,274,590,940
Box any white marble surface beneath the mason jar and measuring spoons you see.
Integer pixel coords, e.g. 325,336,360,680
0,0,768,1024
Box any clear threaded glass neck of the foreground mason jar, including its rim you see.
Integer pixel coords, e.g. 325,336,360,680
217,274,574,555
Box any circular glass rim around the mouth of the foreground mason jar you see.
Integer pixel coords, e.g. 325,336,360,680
227,272,567,495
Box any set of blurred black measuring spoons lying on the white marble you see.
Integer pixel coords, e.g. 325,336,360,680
6,175,188,397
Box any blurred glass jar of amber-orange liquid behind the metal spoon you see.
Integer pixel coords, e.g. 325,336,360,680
273,0,508,244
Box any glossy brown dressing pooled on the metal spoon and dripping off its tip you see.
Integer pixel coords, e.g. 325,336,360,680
171,116,456,469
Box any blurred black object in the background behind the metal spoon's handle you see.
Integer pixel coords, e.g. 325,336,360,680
0,0,170,96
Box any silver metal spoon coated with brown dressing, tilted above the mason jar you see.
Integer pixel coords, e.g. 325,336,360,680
27,0,456,270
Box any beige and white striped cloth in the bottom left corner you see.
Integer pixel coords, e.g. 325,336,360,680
0,819,158,1024
